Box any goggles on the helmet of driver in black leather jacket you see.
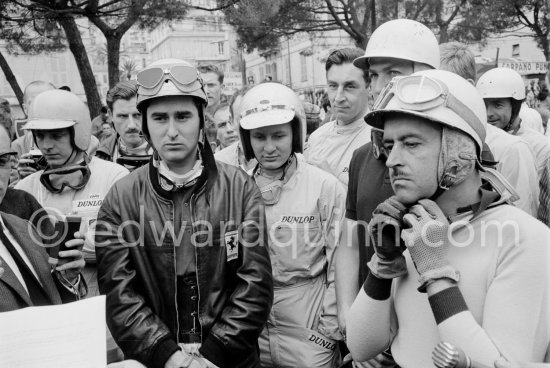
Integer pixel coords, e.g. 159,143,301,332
137,65,203,96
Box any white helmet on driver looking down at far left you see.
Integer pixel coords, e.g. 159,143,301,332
23,89,92,151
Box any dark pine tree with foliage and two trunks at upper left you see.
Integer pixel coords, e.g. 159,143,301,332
0,0,203,116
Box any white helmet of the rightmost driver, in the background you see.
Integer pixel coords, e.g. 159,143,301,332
476,68,525,101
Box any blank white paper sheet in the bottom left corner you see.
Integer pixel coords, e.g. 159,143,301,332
0,295,107,368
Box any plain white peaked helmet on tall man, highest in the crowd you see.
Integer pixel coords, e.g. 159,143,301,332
353,19,440,69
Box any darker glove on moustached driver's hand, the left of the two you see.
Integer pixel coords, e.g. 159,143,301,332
368,196,407,279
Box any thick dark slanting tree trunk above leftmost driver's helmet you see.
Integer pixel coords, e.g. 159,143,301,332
58,17,102,118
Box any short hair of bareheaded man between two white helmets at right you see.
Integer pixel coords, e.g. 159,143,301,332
439,41,477,83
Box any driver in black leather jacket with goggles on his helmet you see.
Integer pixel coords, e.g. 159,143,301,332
96,59,273,368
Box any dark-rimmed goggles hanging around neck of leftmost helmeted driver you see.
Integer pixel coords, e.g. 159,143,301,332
40,156,91,193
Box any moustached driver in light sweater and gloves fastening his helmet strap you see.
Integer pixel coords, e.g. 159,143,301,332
347,70,550,368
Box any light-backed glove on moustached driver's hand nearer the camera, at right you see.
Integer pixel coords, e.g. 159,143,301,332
401,199,459,293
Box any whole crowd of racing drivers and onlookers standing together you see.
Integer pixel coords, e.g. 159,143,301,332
0,19,550,368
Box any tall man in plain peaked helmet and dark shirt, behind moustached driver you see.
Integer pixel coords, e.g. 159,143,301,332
335,19,439,366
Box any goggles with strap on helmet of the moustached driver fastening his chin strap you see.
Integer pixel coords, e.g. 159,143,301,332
373,75,486,138
